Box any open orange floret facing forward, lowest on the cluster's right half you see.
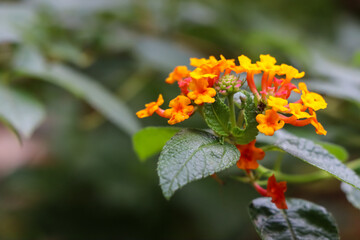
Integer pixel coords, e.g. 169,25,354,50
256,109,285,136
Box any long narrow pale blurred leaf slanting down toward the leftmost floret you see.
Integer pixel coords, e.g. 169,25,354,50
14,46,140,135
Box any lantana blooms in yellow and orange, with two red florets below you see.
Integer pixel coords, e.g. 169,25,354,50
136,55,327,208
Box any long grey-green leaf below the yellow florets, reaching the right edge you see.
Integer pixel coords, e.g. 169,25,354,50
274,131,360,189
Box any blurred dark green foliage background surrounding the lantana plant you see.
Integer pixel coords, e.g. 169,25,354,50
0,0,360,240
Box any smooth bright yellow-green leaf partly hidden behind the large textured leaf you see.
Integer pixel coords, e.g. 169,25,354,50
133,127,180,161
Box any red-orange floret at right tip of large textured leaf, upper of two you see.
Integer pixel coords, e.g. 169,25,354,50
236,139,265,169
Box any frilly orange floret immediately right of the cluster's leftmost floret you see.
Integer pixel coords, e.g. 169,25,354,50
164,95,194,125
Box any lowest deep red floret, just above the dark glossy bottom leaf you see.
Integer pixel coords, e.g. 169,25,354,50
266,174,288,209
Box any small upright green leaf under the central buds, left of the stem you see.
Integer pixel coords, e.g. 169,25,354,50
204,96,230,137
